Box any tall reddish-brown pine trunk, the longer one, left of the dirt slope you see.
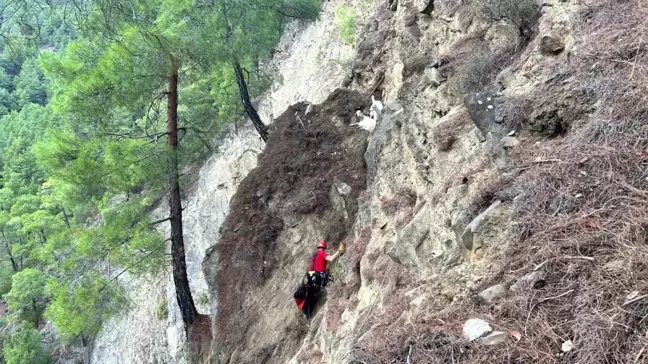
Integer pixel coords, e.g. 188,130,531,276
167,58,198,333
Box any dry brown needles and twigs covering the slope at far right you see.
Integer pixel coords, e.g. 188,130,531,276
355,0,648,364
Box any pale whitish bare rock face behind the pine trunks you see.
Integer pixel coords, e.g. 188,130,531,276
91,0,354,364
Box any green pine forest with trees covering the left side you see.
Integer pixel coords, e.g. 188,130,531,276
0,0,319,364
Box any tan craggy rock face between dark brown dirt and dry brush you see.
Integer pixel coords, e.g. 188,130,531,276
204,0,632,363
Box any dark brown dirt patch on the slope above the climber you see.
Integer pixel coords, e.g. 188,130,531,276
205,90,370,357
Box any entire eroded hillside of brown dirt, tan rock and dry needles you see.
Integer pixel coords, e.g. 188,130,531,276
203,0,648,363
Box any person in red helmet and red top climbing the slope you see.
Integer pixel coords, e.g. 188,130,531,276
295,241,345,318
